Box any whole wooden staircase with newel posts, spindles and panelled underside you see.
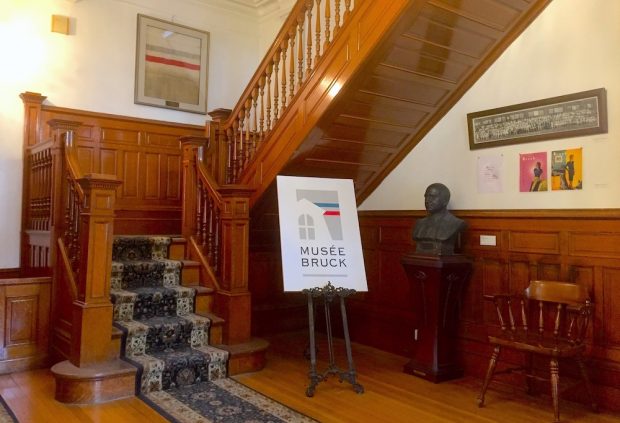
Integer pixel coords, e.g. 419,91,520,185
17,0,550,408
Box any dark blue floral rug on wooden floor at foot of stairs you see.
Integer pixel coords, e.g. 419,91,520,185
140,378,316,423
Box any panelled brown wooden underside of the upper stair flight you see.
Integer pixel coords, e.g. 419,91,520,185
280,0,550,203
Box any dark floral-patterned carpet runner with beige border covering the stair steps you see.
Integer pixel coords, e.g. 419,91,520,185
110,236,228,393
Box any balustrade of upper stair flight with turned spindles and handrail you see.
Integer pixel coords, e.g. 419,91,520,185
210,0,358,184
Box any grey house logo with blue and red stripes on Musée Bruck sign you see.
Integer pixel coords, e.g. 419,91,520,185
296,189,343,241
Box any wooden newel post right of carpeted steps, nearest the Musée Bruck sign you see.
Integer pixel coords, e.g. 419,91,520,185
215,185,253,345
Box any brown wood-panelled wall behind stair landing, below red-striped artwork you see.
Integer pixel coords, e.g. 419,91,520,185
25,97,205,234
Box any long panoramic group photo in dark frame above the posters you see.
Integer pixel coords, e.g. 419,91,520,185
467,88,607,150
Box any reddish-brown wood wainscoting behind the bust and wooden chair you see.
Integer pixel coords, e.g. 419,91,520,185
356,210,620,410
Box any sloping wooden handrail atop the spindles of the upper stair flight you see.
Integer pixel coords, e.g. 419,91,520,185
222,0,308,128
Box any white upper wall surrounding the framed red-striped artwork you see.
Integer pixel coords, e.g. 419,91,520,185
0,0,281,268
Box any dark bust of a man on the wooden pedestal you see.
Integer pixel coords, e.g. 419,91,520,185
413,183,467,255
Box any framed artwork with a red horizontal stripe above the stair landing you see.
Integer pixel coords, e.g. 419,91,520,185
134,15,209,114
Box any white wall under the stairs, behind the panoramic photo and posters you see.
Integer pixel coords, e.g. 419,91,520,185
360,0,620,210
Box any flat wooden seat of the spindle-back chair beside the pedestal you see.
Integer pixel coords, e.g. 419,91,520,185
489,332,586,358
